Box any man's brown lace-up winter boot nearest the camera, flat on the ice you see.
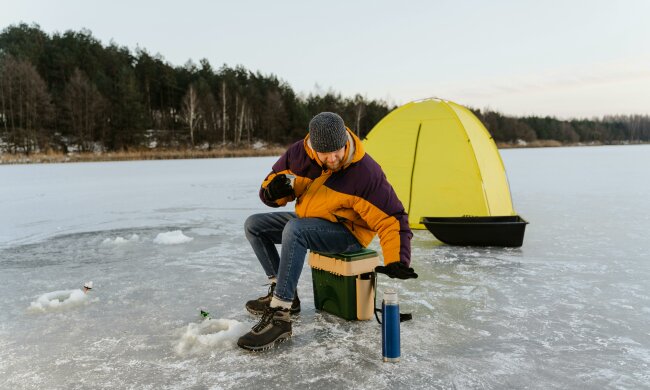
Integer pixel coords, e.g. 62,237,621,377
237,307,291,351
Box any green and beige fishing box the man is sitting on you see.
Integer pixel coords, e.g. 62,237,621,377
309,249,379,320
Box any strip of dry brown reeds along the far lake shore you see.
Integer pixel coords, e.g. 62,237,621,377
0,140,646,165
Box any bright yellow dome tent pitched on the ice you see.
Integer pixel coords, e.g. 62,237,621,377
364,99,525,246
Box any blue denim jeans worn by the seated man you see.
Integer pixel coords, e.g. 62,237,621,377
244,212,363,302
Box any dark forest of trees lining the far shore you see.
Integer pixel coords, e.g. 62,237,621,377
0,24,650,153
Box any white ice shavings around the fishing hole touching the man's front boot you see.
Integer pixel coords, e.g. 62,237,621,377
174,318,249,355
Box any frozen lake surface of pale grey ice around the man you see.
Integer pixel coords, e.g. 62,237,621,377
0,145,650,389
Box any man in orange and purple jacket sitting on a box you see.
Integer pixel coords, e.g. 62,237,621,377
237,112,417,351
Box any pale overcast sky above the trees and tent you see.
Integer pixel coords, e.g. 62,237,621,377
0,0,650,119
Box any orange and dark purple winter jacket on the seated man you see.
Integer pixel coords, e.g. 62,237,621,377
260,129,413,265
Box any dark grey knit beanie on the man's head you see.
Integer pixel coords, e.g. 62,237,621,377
309,112,348,153
